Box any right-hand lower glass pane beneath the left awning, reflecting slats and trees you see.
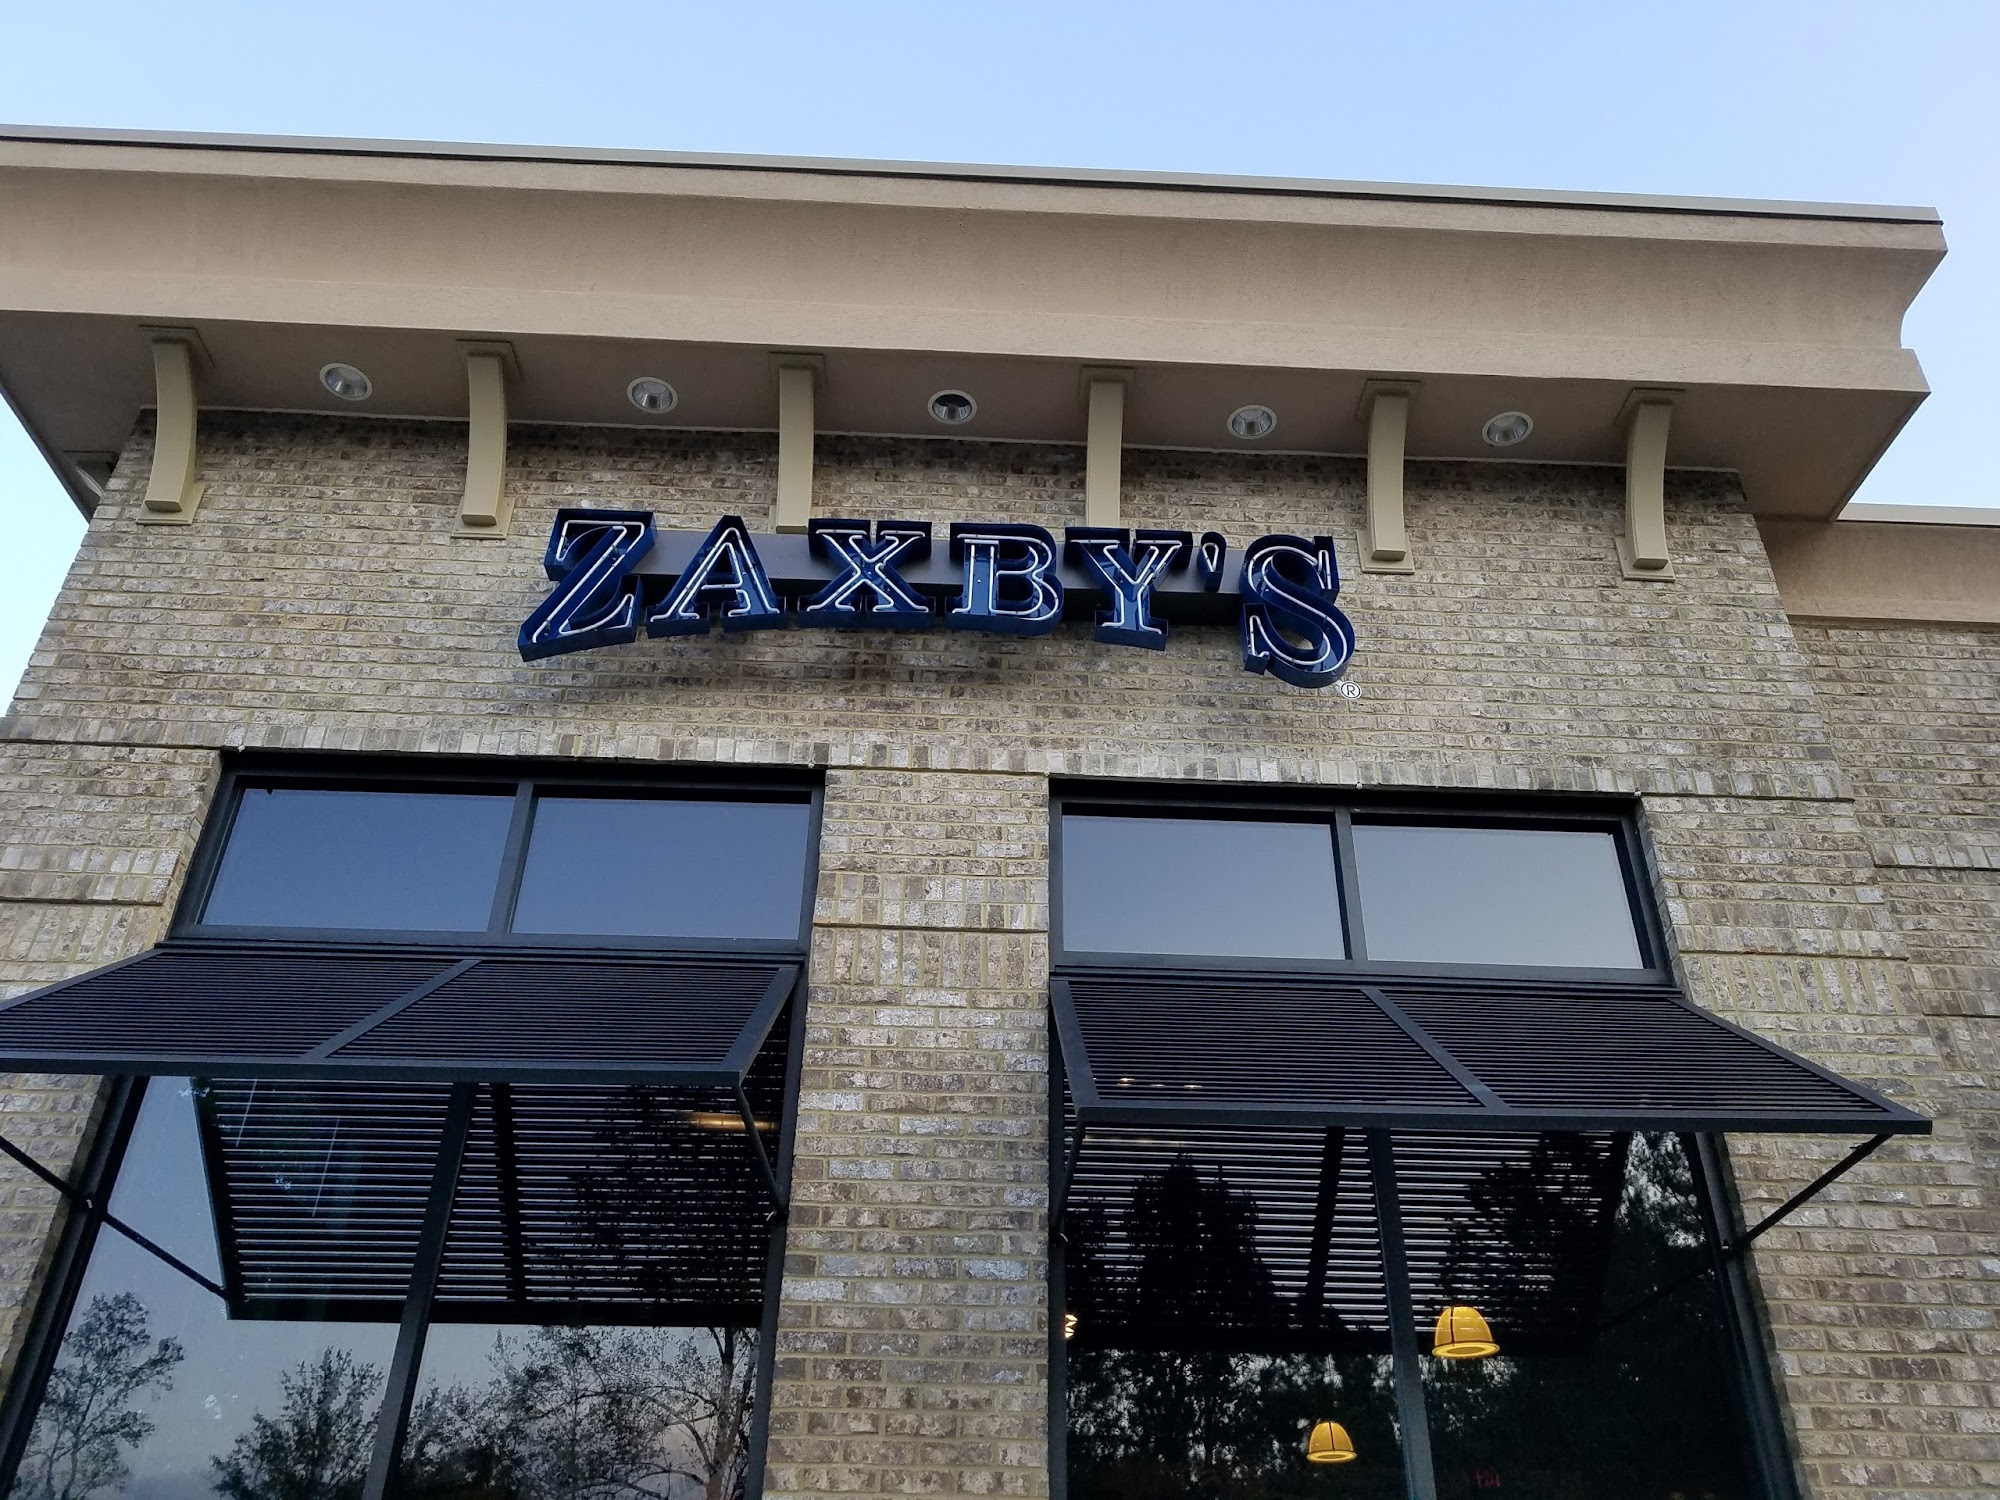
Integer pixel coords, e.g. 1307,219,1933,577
398,1078,778,1500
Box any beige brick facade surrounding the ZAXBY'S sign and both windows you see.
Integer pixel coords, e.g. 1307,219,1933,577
0,414,2000,1500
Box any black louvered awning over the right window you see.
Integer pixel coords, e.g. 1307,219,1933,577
1052,970,1930,1134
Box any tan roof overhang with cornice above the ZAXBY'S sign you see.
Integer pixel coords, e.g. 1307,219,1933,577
0,128,1944,518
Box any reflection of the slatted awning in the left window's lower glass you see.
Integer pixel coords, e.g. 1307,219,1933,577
196,1072,784,1326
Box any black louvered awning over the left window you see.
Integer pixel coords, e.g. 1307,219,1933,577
0,942,798,1088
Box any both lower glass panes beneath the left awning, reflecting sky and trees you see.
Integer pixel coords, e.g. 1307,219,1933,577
12,1080,784,1500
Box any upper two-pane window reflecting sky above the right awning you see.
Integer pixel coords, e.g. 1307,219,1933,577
1056,794,1658,974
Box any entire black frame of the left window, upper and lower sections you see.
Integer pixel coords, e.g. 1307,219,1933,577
0,752,824,1500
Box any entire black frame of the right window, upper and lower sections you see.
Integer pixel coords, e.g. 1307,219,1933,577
1046,780,1802,1500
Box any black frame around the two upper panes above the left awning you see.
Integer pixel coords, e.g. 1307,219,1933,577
168,756,824,954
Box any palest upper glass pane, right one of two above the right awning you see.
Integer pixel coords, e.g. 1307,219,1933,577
1354,822,1644,968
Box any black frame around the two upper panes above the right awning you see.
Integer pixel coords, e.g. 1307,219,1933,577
1048,782,1674,986
